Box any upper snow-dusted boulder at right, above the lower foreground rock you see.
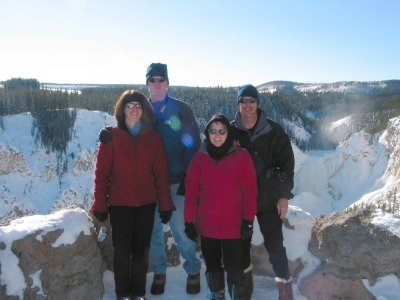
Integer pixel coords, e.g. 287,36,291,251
309,209,400,281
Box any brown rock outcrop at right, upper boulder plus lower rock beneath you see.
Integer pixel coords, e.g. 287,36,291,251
300,210,400,299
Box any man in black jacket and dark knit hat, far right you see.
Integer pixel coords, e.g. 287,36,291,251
231,84,294,300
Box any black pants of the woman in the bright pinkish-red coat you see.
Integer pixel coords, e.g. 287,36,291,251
201,236,244,299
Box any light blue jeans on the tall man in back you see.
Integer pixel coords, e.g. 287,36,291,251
149,183,201,275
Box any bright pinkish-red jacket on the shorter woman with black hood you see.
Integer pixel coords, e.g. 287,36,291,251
185,145,257,239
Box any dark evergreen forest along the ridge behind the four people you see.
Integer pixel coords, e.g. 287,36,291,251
0,78,400,151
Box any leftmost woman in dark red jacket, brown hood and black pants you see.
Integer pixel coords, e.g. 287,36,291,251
91,90,175,299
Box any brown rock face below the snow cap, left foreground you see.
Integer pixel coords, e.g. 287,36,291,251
0,210,104,300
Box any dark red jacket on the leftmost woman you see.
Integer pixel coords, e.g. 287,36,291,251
91,127,175,212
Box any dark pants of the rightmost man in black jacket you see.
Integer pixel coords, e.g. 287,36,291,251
243,209,290,279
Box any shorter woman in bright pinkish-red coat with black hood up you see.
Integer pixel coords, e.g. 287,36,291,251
185,113,257,299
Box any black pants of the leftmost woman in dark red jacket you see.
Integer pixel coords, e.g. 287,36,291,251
110,204,155,297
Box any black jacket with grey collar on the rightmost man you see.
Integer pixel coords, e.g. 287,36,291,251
231,109,294,212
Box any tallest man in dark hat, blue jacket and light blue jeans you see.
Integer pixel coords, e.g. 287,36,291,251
146,63,201,295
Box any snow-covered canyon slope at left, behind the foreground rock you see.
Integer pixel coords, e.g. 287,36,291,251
0,110,114,221
